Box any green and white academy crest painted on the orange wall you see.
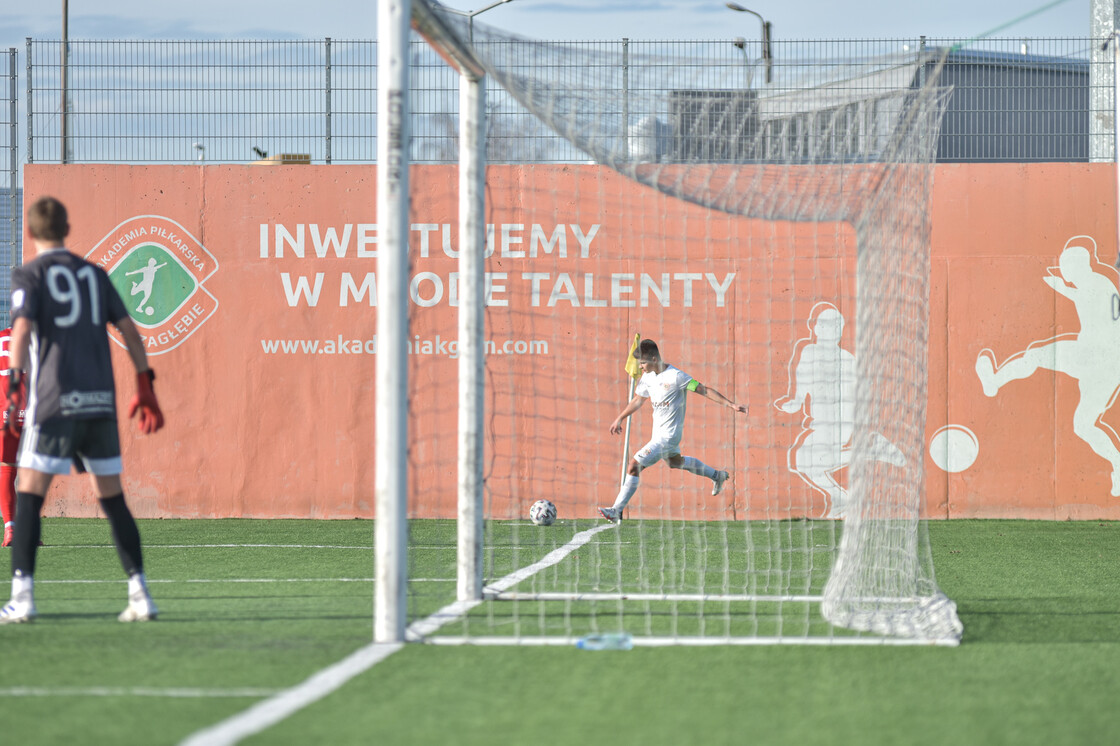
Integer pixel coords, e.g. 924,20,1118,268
85,215,217,355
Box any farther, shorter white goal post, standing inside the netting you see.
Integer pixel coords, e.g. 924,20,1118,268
458,71,486,600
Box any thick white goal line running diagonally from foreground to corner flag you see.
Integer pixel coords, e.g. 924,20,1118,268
180,523,616,746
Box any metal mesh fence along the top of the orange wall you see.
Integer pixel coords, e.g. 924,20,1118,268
26,38,1113,164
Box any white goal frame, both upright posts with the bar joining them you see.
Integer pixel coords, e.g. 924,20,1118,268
374,0,486,642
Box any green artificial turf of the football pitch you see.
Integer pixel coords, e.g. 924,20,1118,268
0,519,1120,746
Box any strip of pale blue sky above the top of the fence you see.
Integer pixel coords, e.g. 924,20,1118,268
0,0,1092,49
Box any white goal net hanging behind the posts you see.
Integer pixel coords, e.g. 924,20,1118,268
409,0,961,644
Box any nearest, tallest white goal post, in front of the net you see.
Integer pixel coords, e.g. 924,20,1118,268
373,0,411,642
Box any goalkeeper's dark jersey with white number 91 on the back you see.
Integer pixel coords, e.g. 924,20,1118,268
11,249,128,425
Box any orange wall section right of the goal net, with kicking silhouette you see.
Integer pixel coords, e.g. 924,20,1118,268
927,164,1120,520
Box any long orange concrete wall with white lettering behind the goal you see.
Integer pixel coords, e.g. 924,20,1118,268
25,164,1120,519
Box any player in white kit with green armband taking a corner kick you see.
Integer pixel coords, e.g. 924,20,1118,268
599,339,747,523
